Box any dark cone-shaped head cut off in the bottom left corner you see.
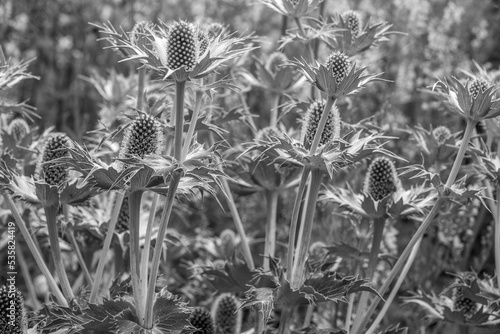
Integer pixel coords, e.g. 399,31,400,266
0,285,28,334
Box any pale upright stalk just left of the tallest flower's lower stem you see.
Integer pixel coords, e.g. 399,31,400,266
128,190,145,325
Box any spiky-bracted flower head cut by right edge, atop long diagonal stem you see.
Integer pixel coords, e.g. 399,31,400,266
433,78,500,122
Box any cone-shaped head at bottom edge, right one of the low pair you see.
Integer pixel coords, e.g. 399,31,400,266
212,293,241,334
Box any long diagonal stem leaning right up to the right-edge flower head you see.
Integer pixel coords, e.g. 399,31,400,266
353,120,477,334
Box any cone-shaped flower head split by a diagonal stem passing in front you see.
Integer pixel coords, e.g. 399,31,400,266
302,101,340,147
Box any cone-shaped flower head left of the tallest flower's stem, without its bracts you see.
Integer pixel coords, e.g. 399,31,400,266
120,114,163,158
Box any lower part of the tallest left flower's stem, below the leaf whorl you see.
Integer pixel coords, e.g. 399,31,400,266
145,173,182,329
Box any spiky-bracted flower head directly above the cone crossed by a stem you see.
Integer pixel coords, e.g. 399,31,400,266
290,51,383,99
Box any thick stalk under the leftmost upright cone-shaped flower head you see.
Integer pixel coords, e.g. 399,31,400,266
44,205,75,301
